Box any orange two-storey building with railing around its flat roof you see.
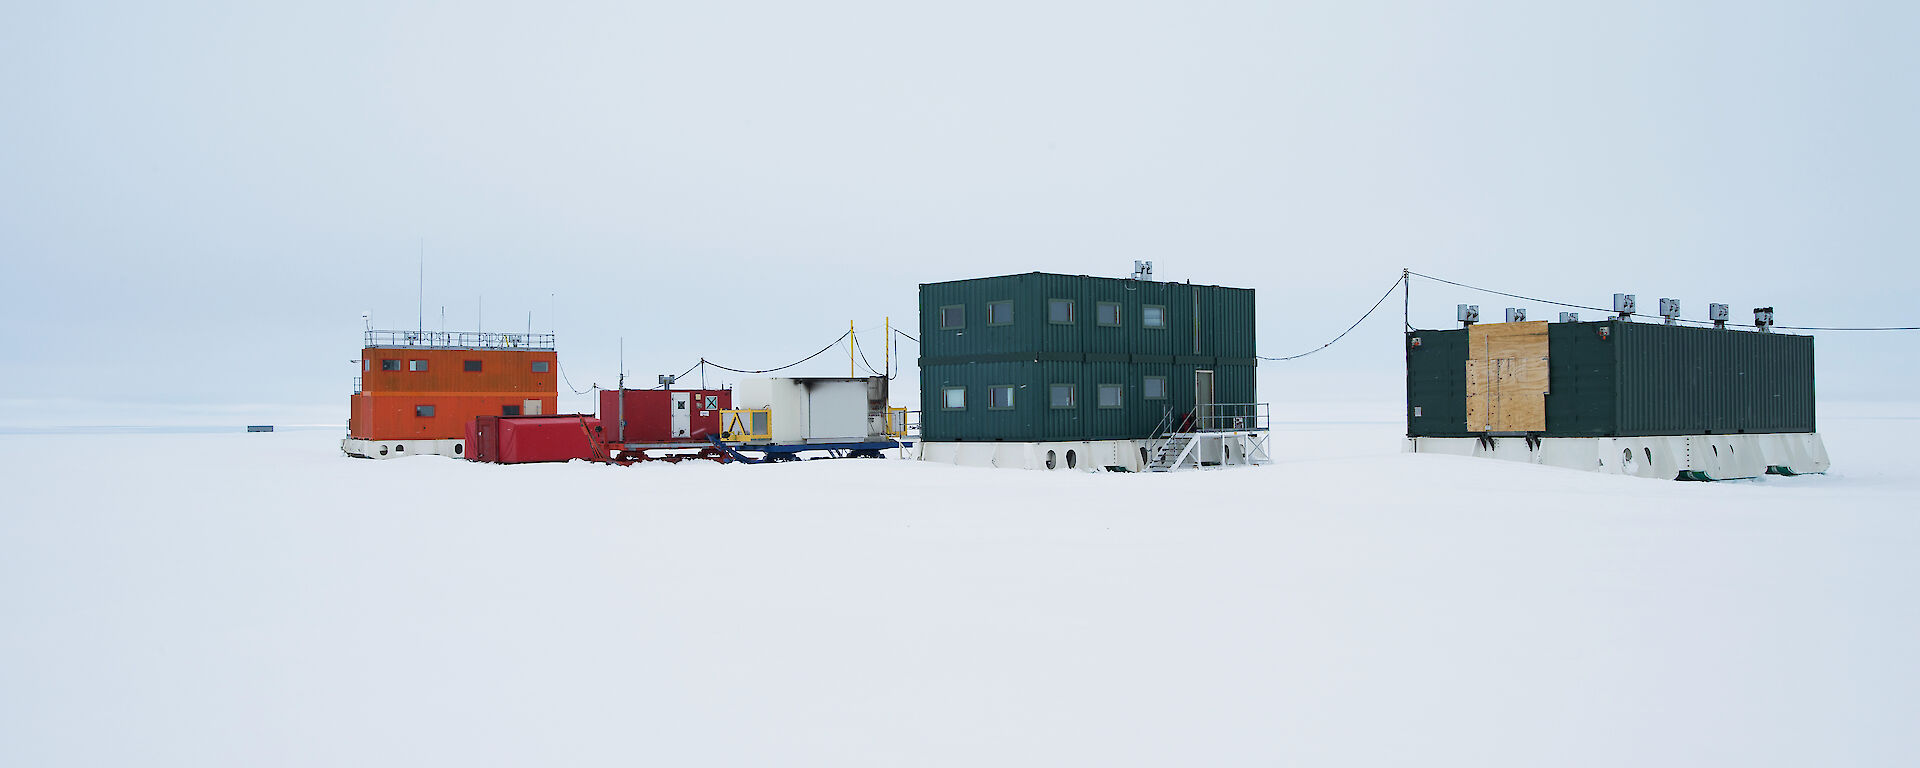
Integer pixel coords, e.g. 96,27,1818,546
340,330,559,459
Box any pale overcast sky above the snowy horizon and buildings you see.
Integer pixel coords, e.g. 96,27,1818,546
0,0,1920,420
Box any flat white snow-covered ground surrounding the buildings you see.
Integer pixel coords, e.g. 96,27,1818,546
0,405,1920,766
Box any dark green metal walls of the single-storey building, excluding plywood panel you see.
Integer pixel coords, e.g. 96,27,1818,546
1405,319,1814,438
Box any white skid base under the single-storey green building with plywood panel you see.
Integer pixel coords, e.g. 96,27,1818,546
1405,432,1830,480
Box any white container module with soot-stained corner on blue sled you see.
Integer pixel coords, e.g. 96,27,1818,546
733,376,887,445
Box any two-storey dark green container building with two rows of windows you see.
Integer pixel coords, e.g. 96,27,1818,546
920,273,1256,442
